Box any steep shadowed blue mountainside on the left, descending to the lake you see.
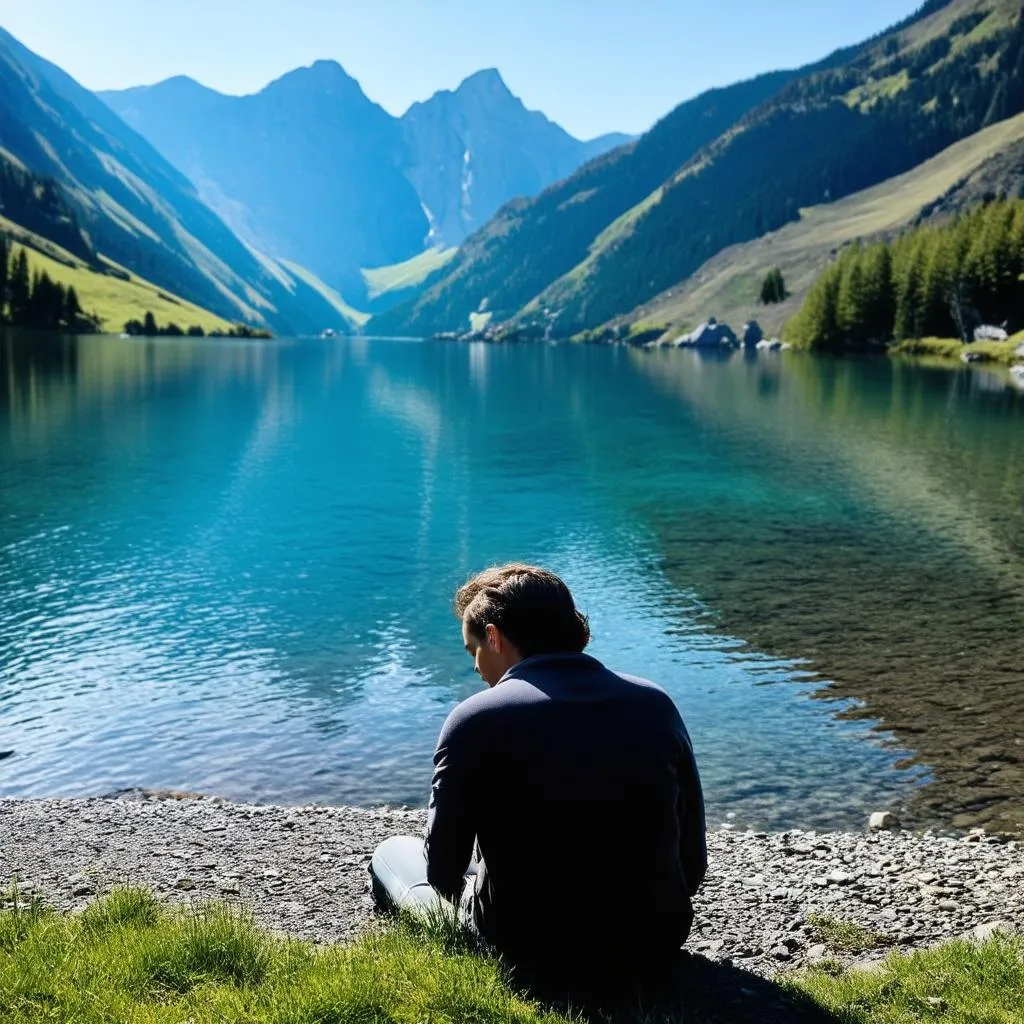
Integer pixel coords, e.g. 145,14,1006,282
0,29,356,331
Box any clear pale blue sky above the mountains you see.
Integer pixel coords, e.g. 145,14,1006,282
0,0,921,137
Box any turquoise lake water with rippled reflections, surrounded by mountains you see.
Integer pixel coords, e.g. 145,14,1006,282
0,333,1024,828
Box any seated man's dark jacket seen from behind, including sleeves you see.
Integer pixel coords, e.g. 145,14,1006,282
427,653,706,964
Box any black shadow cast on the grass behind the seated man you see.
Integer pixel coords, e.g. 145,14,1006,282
510,951,840,1024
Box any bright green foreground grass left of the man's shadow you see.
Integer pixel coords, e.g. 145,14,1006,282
0,889,560,1024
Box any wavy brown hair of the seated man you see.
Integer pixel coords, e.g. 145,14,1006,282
455,562,590,657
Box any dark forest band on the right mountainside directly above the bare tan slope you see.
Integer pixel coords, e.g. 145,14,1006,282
544,14,1024,333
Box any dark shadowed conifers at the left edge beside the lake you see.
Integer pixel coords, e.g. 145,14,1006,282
0,234,100,334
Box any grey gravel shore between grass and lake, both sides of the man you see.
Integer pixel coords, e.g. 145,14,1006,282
0,798,1024,977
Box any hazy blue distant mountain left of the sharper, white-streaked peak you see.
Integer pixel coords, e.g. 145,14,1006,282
101,60,430,292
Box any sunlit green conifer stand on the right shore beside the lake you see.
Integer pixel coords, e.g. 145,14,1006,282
786,200,1024,352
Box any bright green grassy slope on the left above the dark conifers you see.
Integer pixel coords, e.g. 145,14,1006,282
0,217,231,334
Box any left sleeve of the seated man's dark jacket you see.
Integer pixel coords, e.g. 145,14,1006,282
425,709,479,904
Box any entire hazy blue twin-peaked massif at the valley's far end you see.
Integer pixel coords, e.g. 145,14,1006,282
100,61,625,302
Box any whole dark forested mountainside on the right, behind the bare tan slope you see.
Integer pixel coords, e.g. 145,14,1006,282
370,0,1024,335
